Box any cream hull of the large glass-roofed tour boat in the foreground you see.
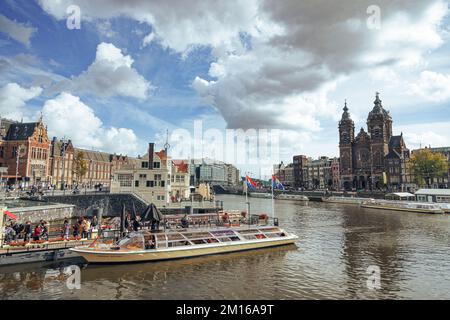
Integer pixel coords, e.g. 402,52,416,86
71,236,298,264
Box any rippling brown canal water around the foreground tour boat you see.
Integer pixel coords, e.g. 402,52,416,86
0,195,450,299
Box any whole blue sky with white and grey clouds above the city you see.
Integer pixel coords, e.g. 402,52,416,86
0,0,450,175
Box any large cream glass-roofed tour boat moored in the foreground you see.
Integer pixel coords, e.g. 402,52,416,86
70,226,298,263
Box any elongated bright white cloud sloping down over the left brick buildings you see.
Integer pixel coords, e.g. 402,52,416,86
42,92,138,154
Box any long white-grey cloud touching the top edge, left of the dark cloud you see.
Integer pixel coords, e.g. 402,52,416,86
39,0,257,52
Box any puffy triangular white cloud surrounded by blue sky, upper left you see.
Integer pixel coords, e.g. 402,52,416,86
70,42,152,100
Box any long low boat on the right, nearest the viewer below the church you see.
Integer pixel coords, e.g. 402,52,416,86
361,199,445,213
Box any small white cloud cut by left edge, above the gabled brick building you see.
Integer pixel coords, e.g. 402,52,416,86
0,82,42,121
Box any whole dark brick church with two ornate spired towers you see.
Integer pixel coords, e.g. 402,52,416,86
339,92,410,190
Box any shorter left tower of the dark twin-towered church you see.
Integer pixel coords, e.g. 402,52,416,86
339,101,355,188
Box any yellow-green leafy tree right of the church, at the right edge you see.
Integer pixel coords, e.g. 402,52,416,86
408,148,448,187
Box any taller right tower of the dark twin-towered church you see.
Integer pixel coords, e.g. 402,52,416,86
367,92,392,175
